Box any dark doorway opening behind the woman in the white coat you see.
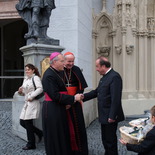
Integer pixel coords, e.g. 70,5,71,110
0,19,27,98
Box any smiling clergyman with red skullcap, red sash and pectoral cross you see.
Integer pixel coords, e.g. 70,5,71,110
62,52,88,155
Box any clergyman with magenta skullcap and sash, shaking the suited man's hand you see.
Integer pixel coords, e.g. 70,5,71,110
42,52,81,155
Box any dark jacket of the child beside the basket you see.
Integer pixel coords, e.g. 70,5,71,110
126,126,155,155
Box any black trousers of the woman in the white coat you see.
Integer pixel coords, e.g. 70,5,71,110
20,119,42,147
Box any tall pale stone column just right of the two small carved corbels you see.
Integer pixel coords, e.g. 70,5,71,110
138,0,148,98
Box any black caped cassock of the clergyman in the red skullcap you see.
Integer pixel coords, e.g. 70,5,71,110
62,65,88,155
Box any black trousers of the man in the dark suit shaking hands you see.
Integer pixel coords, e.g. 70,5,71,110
101,123,118,155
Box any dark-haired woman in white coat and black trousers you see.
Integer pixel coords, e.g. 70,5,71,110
18,64,43,150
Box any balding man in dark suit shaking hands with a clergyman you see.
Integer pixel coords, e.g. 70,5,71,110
84,56,124,155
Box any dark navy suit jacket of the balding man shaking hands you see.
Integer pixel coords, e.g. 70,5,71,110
84,69,124,124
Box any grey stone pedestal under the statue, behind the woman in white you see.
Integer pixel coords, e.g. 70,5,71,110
12,44,64,140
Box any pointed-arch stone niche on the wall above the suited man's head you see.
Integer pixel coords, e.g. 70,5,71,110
92,12,113,86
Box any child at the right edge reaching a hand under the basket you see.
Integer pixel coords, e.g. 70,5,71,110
119,106,155,155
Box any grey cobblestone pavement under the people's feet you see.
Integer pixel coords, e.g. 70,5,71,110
0,102,135,155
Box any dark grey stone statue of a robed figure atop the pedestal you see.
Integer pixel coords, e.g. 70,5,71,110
16,0,58,44
